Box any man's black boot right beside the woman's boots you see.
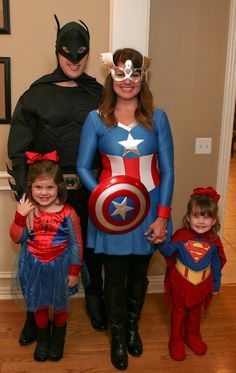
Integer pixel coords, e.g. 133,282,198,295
85,290,107,331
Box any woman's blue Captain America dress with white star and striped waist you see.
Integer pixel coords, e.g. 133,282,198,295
77,110,174,255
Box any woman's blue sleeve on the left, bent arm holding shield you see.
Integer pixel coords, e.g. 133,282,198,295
76,112,98,192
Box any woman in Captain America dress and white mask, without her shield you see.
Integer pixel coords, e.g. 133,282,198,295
77,48,174,370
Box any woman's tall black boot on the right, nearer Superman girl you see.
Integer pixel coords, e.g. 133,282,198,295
127,280,148,356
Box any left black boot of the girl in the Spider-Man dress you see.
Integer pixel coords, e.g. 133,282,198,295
34,325,51,361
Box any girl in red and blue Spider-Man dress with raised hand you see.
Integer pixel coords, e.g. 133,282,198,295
10,151,83,361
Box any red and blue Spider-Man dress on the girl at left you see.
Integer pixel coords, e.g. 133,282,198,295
10,204,83,312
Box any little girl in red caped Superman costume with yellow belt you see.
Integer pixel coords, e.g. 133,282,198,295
160,187,226,360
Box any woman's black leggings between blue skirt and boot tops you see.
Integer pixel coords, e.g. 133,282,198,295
103,254,152,290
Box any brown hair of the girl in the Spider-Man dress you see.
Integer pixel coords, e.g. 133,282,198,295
26,160,67,204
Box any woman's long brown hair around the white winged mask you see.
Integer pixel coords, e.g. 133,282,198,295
99,48,154,130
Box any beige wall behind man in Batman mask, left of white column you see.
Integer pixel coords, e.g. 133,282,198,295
0,0,110,294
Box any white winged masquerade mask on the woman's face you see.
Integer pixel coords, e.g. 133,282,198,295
101,52,151,83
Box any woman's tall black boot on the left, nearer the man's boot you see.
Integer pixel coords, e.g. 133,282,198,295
105,289,128,370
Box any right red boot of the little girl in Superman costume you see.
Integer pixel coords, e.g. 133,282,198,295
185,304,207,355
